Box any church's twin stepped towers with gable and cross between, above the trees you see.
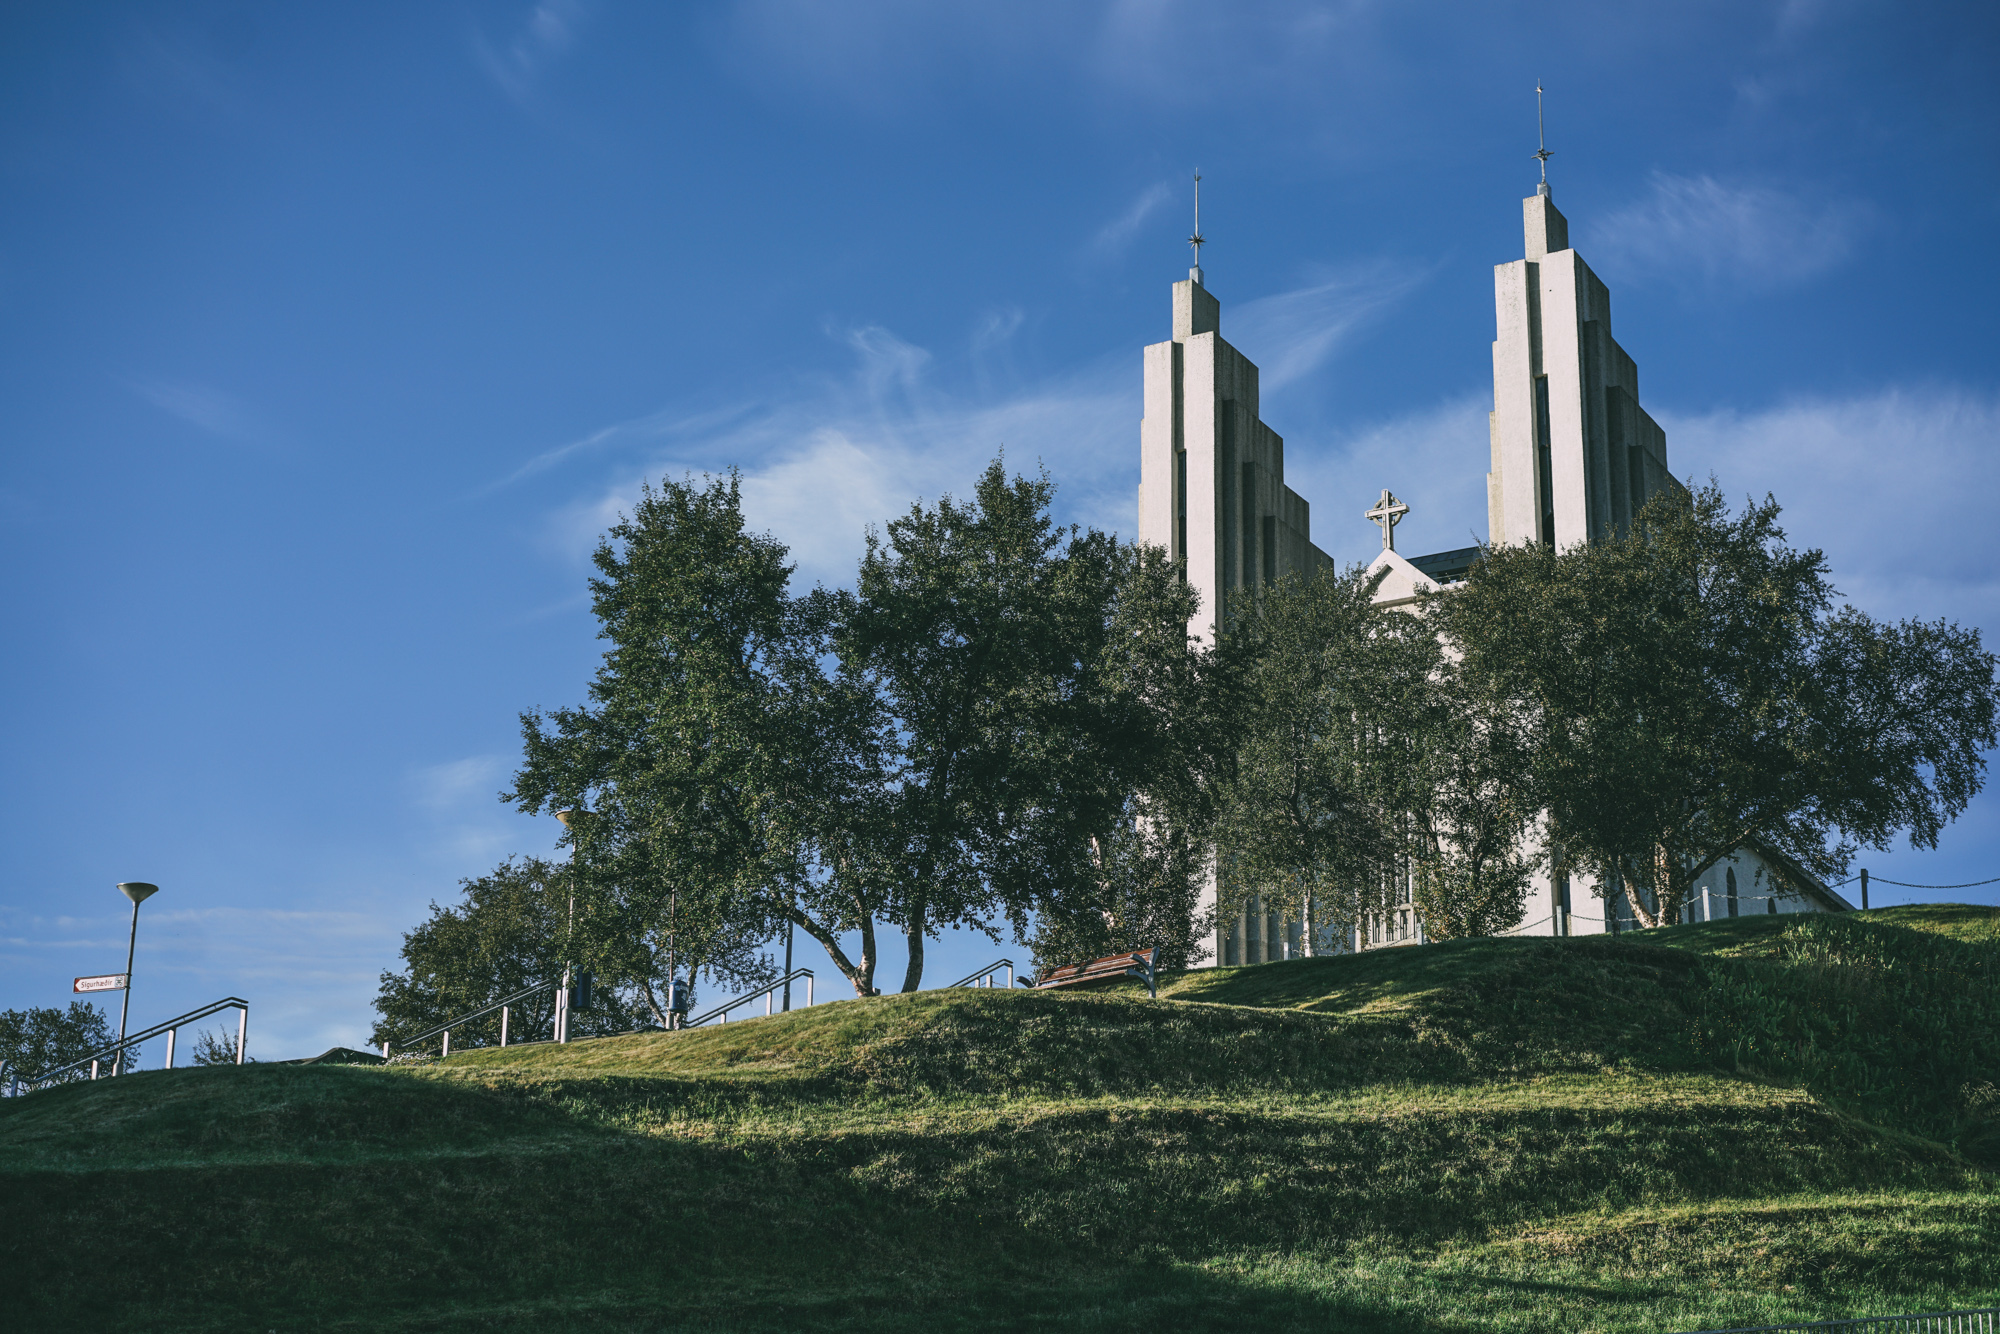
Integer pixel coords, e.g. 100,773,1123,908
1138,184,1672,652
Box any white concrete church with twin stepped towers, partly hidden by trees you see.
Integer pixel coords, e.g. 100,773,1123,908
1138,180,1850,966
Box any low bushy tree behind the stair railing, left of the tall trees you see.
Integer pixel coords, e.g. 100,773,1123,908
370,858,648,1060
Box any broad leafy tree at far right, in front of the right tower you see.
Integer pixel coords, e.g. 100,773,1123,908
1430,482,2000,926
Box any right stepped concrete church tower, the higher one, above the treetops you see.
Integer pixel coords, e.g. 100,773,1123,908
1486,180,1674,548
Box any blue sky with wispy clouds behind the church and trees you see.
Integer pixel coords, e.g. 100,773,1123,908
0,0,2000,1058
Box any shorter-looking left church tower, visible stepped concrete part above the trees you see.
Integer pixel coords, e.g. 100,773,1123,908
1138,268,1332,640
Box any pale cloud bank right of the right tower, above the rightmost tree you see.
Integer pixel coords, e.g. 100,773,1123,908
1660,386,2000,634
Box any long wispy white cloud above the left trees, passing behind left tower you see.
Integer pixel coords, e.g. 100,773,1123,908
502,264,1432,584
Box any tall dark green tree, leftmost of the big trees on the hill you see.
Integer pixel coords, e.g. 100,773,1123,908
502,474,886,994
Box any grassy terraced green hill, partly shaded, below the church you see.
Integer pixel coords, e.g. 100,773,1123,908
0,906,2000,1330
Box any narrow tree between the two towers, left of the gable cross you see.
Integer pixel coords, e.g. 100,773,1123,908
1218,566,1438,948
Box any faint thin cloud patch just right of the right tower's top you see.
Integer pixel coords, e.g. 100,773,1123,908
1586,172,1868,288
